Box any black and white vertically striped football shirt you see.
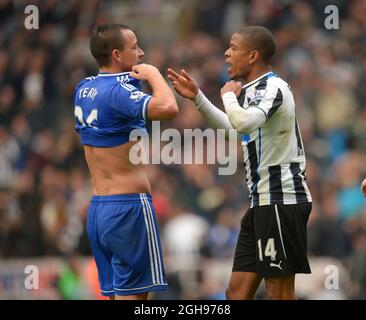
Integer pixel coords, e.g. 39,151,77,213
238,72,312,207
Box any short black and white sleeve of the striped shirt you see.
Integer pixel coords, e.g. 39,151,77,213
248,85,283,120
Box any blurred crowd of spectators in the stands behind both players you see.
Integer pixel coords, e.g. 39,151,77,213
0,0,366,299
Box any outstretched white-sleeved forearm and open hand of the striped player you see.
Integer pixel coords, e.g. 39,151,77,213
168,69,233,130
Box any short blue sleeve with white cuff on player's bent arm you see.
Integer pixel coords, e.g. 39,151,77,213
110,83,151,120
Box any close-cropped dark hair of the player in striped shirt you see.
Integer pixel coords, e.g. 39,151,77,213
239,26,276,64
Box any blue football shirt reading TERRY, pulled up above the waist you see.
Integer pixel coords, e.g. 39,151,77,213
74,72,151,147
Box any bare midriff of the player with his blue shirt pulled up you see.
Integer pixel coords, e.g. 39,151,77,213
84,142,151,195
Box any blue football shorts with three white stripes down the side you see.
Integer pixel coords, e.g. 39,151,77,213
87,193,168,296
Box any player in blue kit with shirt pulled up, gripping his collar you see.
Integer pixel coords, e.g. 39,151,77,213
74,24,178,299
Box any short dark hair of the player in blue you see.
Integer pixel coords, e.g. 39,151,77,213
89,24,130,67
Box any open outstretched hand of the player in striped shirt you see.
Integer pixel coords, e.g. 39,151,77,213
167,68,198,100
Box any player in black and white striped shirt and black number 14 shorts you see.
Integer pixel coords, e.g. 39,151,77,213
168,26,312,299
